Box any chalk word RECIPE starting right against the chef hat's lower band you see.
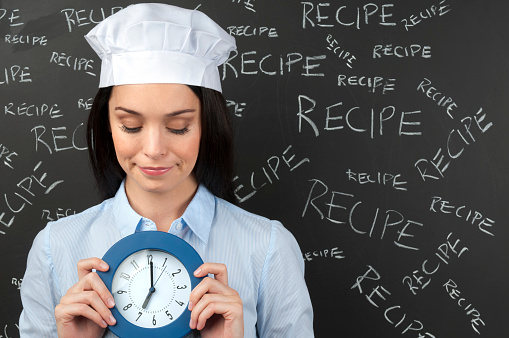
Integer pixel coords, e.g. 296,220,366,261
222,50,326,80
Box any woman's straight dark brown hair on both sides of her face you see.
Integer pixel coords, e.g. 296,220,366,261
87,86,235,203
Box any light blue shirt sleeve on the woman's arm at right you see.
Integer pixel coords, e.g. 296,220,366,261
256,221,314,338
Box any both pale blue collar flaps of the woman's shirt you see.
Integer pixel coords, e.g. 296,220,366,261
113,181,216,244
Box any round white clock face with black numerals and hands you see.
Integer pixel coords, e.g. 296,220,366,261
111,249,192,328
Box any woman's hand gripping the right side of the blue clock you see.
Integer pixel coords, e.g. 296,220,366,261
189,263,244,338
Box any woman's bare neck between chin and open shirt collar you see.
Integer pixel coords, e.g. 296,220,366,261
125,178,198,232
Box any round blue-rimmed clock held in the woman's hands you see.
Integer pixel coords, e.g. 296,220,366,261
97,231,203,337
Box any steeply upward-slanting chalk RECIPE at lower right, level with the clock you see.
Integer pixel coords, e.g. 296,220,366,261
402,232,468,295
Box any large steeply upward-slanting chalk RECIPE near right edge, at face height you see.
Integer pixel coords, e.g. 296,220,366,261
414,108,493,181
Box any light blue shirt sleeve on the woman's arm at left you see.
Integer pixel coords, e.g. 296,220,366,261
19,226,61,338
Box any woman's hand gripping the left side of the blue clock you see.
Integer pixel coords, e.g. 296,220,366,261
55,258,115,337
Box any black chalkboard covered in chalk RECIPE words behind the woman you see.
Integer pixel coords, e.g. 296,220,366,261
0,0,509,337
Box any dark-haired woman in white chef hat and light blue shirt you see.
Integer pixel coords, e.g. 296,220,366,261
20,4,313,337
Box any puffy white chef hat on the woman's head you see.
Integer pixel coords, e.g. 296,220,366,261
85,3,236,91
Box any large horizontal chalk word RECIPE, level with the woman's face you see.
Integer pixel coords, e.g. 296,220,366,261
297,95,422,139
